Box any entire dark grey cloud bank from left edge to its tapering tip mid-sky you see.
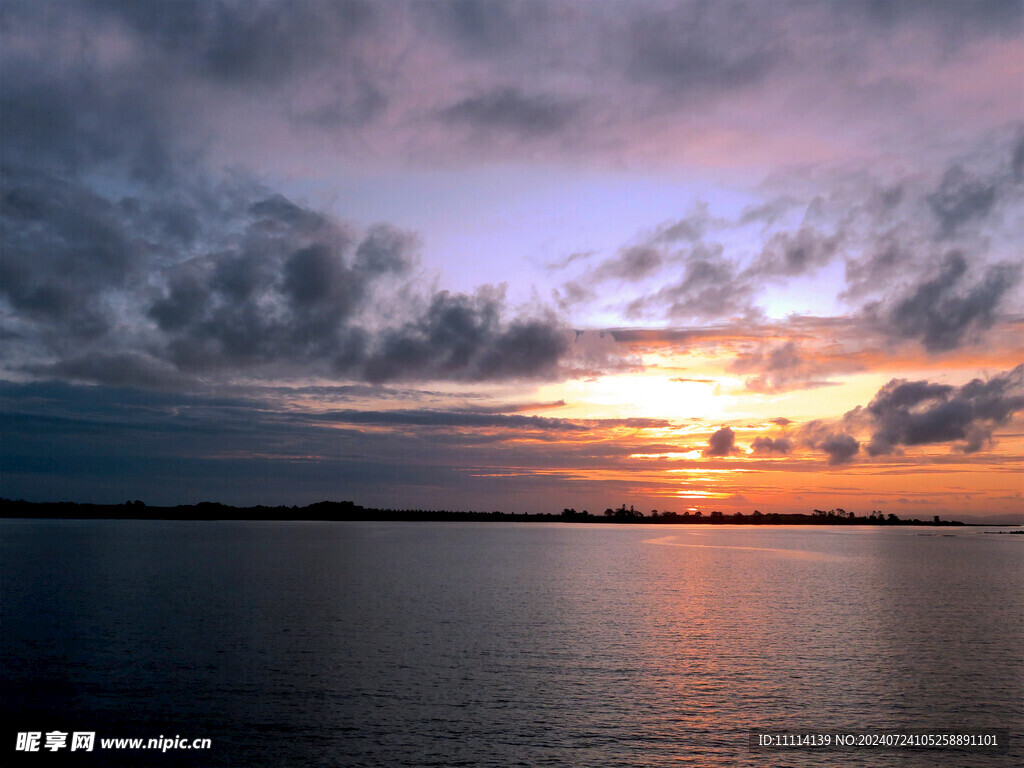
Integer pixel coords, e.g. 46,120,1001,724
0,161,581,382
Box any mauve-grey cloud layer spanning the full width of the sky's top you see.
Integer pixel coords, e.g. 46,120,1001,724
3,0,1022,177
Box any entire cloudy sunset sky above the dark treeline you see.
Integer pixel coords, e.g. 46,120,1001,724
0,0,1024,521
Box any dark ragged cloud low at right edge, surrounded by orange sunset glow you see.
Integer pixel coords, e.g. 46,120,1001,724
853,366,1024,456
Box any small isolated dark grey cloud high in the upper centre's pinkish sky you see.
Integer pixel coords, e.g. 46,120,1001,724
440,88,578,136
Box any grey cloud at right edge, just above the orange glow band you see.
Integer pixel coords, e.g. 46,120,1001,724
865,252,1021,352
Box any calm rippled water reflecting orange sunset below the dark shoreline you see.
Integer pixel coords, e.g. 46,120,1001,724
0,520,1024,767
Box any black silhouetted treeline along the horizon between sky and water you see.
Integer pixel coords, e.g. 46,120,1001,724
0,499,965,525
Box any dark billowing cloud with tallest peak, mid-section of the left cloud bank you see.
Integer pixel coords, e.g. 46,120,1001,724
147,196,380,371
